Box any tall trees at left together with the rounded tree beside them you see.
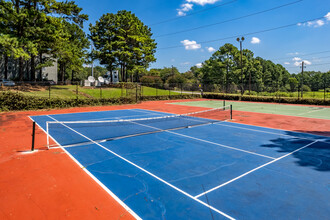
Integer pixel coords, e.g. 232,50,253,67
0,0,156,81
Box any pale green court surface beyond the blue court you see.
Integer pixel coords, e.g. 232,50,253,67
173,100,330,120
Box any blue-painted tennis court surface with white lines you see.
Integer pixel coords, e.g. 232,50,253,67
31,109,330,219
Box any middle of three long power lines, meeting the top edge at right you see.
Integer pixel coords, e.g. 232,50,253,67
155,0,303,38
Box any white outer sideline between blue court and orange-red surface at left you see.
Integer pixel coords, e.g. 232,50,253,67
28,115,142,220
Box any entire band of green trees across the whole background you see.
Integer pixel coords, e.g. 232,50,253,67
0,0,330,92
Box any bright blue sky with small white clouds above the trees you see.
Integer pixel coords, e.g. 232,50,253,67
76,0,330,73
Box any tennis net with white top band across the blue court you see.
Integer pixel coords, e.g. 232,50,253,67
46,106,232,147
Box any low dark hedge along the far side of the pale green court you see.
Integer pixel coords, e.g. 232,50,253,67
203,94,330,105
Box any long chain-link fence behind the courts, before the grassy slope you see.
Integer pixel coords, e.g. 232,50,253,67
0,81,330,101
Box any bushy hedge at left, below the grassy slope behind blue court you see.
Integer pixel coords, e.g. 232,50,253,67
0,92,135,111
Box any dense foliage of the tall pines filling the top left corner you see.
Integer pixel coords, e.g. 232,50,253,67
0,0,88,80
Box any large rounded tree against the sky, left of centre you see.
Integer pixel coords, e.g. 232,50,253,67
89,10,156,81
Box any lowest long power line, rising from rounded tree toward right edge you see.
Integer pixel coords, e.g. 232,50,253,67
158,17,324,50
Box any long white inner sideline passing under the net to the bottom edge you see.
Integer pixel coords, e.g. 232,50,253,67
48,115,234,220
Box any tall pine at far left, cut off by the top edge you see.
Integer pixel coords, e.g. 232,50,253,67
0,0,88,80
